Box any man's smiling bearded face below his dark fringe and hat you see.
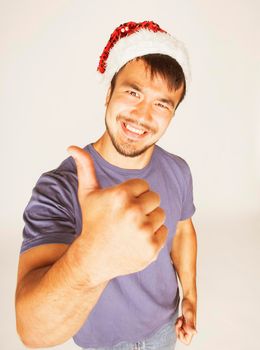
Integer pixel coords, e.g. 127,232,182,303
105,60,183,157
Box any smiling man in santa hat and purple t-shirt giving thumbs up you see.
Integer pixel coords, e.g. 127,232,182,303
16,21,197,349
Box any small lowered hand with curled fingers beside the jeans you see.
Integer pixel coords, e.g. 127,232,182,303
175,298,198,345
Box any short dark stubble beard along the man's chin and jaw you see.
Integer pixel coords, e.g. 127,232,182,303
105,114,155,158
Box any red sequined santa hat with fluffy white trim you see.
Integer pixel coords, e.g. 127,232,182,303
97,21,191,89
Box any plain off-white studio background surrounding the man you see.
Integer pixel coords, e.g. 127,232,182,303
0,0,260,350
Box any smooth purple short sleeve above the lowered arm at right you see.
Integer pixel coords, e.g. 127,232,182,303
180,161,196,220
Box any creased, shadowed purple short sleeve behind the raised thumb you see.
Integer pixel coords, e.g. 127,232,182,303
20,170,76,253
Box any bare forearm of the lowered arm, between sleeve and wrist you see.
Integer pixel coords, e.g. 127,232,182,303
172,230,197,303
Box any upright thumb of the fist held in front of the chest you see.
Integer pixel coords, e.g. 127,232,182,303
67,146,100,196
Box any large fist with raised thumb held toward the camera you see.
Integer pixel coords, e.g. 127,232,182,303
67,146,168,283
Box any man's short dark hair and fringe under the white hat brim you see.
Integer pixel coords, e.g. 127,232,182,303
110,53,186,109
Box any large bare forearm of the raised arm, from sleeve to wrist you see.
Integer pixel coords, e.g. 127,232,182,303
16,237,109,348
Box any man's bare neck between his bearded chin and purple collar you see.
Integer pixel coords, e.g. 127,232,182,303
93,131,154,169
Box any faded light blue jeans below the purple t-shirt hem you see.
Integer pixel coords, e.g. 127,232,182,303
82,310,178,350
